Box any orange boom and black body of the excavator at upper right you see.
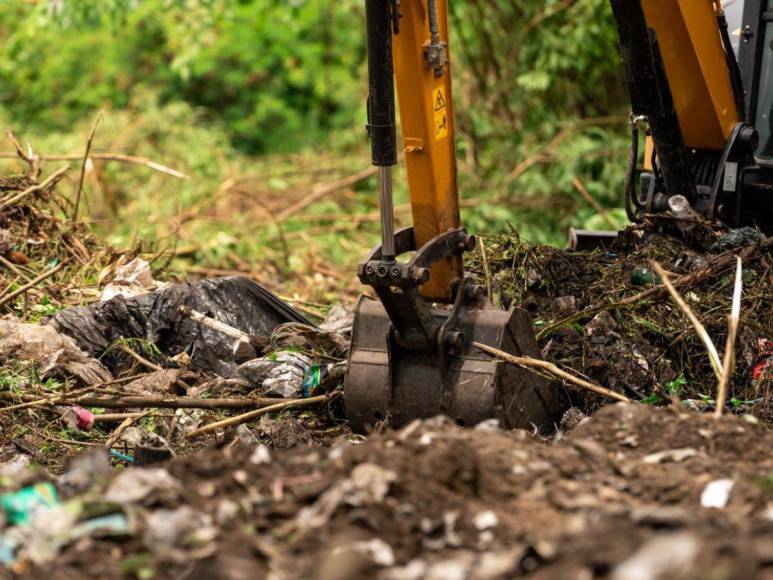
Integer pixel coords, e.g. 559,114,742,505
610,0,773,234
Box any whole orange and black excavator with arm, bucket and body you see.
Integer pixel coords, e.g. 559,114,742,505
344,0,773,432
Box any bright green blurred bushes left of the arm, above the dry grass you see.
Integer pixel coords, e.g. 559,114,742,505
0,0,364,152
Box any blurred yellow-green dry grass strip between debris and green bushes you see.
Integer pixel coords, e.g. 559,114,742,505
0,95,624,306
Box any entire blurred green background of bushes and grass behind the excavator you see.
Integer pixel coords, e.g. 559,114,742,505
0,0,628,278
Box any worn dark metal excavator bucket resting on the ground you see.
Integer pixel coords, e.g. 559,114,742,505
344,228,561,432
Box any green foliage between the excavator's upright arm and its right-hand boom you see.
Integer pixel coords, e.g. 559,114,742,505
450,0,627,243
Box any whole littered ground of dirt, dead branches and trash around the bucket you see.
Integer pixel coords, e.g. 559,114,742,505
0,153,773,580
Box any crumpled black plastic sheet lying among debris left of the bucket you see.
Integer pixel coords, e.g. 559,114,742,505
49,276,313,377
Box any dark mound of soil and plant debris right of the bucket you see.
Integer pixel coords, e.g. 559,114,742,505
469,230,773,417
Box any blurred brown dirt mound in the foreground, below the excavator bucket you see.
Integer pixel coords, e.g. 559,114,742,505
17,405,773,579
